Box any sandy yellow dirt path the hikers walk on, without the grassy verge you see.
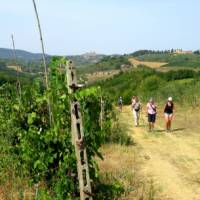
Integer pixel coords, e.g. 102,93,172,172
120,107,200,200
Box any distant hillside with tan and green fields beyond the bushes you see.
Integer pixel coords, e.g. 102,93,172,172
78,53,200,83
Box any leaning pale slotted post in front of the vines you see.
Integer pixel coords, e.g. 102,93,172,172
66,61,93,200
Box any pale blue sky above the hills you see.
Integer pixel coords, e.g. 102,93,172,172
0,0,200,55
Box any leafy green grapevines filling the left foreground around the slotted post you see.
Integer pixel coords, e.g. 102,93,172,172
0,57,130,200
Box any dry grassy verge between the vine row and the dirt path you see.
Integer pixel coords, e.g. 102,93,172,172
98,144,160,200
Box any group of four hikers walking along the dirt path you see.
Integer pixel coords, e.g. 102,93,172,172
118,96,174,132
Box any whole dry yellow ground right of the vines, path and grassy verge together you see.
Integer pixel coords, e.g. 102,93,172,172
99,106,200,200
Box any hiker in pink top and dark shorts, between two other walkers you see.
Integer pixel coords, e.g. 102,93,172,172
147,98,157,132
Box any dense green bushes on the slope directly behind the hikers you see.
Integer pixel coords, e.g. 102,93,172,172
98,66,200,105
